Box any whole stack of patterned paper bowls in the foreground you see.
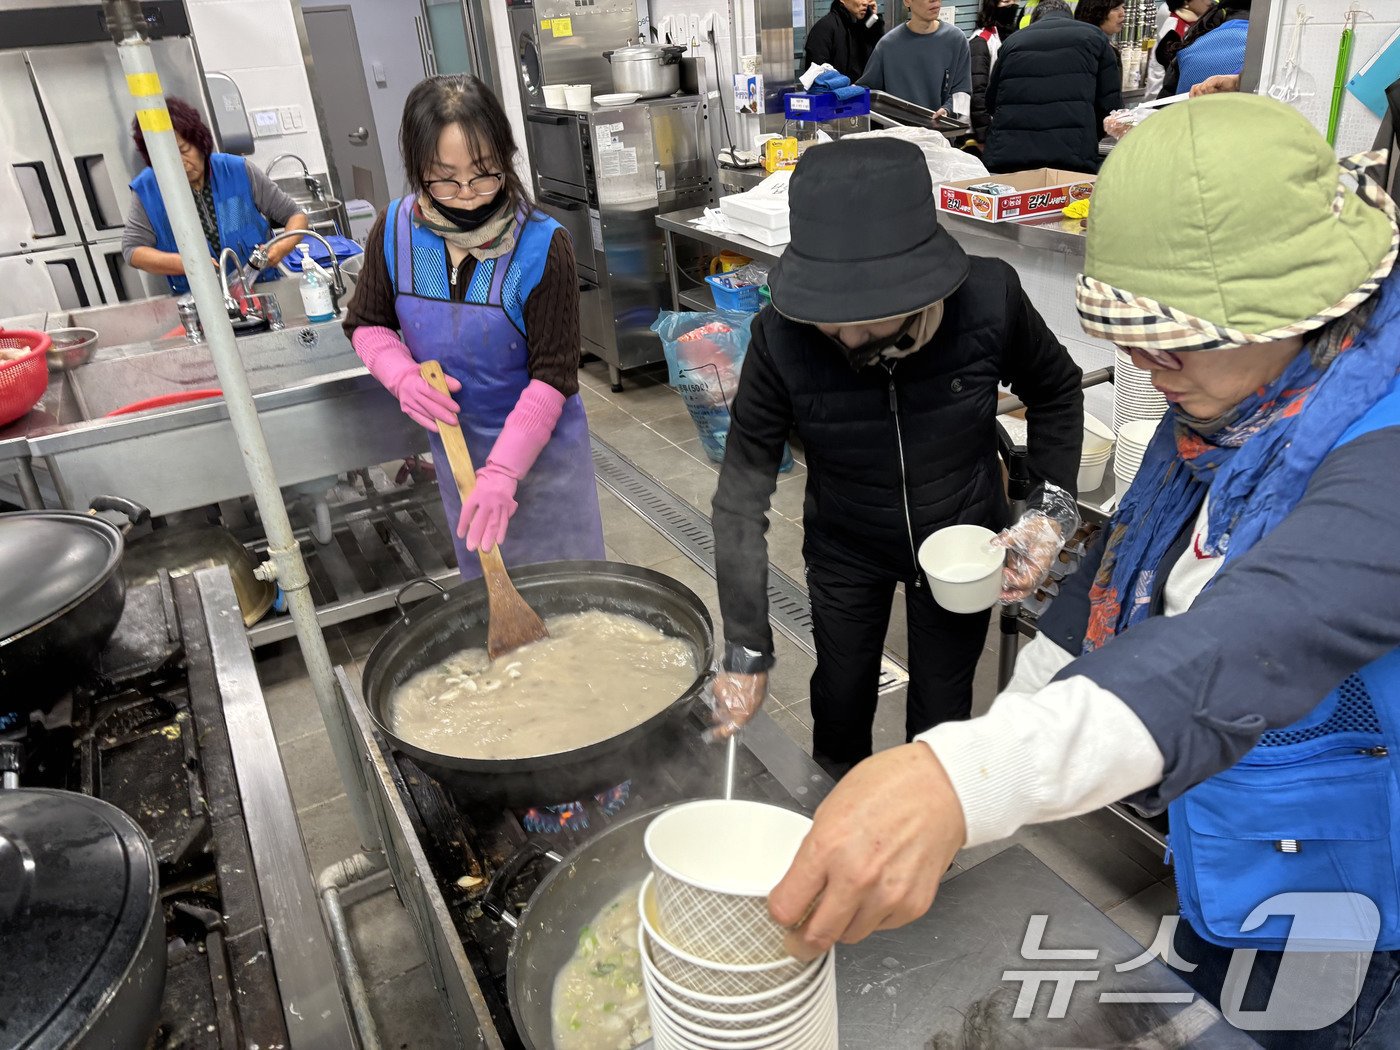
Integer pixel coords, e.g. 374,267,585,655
637,799,839,1050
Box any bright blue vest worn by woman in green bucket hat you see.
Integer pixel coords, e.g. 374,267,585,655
1168,378,1400,951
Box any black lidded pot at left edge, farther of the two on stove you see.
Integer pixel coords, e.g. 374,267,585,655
0,511,126,725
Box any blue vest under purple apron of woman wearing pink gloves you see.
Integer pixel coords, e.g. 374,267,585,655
384,197,560,333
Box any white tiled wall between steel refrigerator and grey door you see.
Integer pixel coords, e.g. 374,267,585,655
186,0,326,175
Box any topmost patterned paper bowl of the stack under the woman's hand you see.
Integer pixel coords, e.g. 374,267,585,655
643,798,812,963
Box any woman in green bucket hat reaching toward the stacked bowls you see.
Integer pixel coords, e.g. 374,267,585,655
769,94,1400,1050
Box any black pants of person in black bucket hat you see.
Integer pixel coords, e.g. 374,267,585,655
806,554,988,767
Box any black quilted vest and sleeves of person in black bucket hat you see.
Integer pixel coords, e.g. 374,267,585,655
713,258,1084,655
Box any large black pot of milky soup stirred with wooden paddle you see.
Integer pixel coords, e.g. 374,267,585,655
363,561,714,805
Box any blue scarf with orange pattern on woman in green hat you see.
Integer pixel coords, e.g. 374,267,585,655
1084,277,1400,652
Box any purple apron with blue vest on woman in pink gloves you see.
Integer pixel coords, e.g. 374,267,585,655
385,197,606,580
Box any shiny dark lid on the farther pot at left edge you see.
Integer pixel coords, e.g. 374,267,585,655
0,511,122,641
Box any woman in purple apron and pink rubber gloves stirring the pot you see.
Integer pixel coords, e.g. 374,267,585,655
344,76,603,580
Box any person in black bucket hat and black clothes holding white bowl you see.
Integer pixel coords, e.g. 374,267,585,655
713,139,1084,777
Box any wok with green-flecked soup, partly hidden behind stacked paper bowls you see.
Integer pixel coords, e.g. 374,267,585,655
482,806,666,1050
